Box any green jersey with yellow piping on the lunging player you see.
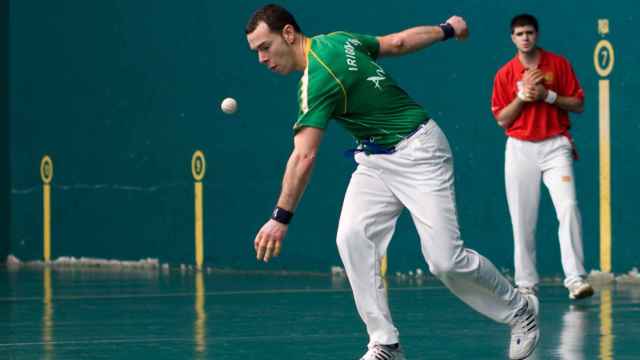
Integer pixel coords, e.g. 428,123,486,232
293,32,428,147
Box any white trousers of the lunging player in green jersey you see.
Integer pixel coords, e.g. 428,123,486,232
337,120,525,345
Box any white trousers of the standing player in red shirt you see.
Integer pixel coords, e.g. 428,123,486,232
504,135,585,287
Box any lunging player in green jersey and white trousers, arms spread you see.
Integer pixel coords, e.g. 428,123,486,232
245,5,539,360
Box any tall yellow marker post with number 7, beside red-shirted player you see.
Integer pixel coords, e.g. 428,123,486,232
593,19,615,273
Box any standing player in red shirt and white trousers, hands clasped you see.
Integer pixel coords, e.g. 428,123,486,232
491,14,593,299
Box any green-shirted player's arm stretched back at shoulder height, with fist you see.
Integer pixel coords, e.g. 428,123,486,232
378,16,469,56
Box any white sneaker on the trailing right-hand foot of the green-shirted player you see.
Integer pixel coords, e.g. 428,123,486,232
509,295,540,360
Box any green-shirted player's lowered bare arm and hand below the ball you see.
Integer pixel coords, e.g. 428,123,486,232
253,127,324,262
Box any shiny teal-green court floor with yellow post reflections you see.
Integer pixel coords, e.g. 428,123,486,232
0,269,640,360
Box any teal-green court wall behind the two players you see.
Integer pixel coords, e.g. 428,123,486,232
10,0,640,274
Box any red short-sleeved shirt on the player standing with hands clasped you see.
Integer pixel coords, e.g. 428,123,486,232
491,49,584,141
